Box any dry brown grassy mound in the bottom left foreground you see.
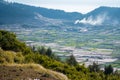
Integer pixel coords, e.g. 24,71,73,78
0,63,68,80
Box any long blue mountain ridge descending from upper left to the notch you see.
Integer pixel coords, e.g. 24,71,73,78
0,0,82,23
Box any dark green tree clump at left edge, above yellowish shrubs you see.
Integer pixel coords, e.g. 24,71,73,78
0,30,31,54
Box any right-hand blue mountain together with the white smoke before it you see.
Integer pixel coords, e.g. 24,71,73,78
76,7,120,25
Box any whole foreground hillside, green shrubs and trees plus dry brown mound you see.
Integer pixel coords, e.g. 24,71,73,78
0,30,120,80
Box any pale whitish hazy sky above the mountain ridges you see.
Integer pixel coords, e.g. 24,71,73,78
6,0,120,13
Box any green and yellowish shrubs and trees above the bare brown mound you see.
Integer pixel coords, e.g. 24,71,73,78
0,30,120,80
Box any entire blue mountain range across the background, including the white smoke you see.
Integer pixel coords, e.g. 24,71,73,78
0,0,120,26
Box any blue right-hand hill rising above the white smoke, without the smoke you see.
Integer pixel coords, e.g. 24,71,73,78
85,6,120,23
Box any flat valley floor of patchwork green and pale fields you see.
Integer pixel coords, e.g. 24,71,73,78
1,24,120,68
